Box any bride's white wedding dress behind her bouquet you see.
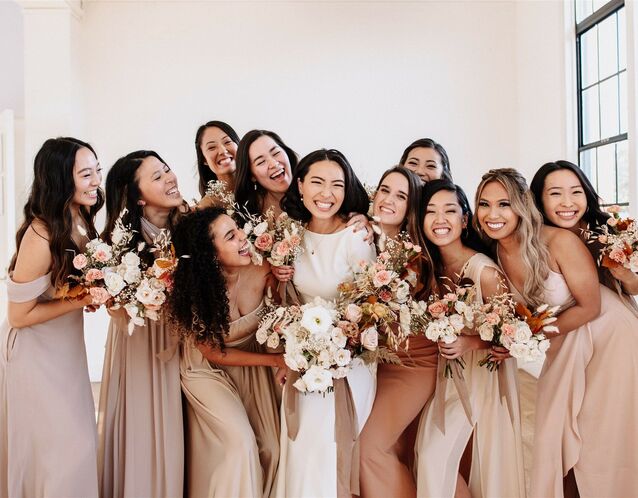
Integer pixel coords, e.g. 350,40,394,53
275,228,376,498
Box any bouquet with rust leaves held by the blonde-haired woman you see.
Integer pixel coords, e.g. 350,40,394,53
476,294,559,371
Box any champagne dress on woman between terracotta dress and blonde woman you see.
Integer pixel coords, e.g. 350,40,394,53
416,253,525,498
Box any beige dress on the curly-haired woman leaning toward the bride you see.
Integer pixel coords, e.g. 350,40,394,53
180,304,279,498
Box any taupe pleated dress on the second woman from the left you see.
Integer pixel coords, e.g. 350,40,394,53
98,220,184,498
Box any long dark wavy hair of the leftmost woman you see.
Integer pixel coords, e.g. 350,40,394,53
9,137,104,287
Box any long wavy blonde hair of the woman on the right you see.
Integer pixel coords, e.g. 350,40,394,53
472,168,549,306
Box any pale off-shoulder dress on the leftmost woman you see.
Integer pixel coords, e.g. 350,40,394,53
0,274,98,497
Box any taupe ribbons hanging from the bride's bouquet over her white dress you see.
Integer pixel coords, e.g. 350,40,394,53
284,371,359,498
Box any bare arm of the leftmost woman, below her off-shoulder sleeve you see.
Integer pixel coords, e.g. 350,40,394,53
7,222,93,328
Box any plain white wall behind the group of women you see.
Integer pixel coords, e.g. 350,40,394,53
5,0,570,379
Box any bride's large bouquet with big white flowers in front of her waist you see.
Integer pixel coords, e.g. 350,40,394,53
256,297,370,393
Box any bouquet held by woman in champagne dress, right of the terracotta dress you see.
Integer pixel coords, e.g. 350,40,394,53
411,280,476,377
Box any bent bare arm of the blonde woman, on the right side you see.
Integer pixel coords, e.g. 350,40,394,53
547,229,600,337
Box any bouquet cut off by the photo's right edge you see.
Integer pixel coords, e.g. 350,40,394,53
589,206,638,273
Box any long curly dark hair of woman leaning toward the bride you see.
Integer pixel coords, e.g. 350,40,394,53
168,207,230,349
